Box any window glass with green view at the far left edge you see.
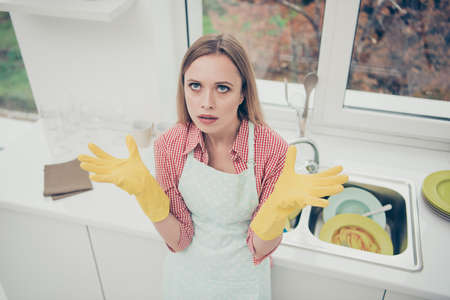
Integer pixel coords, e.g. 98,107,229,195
0,12,37,119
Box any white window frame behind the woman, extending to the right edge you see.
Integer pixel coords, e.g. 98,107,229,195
186,0,450,151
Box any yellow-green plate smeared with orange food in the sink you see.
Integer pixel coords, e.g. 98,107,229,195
319,214,394,255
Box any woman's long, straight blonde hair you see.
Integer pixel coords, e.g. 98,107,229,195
177,34,265,125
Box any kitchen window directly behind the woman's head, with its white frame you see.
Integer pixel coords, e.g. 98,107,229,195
187,0,325,124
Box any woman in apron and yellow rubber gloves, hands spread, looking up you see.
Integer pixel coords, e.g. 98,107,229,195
79,35,347,299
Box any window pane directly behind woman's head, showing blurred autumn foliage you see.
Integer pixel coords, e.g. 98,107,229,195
203,0,325,83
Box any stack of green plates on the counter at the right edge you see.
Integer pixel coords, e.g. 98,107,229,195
422,170,450,221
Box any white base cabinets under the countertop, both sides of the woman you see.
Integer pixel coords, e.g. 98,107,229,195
0,208,436,300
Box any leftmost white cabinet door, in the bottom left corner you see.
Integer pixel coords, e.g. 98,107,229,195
0,209,103,300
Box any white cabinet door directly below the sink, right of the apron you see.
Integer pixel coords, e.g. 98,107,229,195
272,266,384,300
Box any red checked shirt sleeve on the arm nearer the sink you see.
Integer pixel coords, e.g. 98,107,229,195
247,135,288,265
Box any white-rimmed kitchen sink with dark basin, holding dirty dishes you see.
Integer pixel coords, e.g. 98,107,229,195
282,172,422,271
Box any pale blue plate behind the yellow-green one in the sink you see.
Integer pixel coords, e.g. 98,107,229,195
323,187,386,228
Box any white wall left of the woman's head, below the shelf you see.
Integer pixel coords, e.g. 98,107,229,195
11,0,187,148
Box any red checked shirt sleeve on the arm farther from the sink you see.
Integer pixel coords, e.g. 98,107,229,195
154,137,194,252
